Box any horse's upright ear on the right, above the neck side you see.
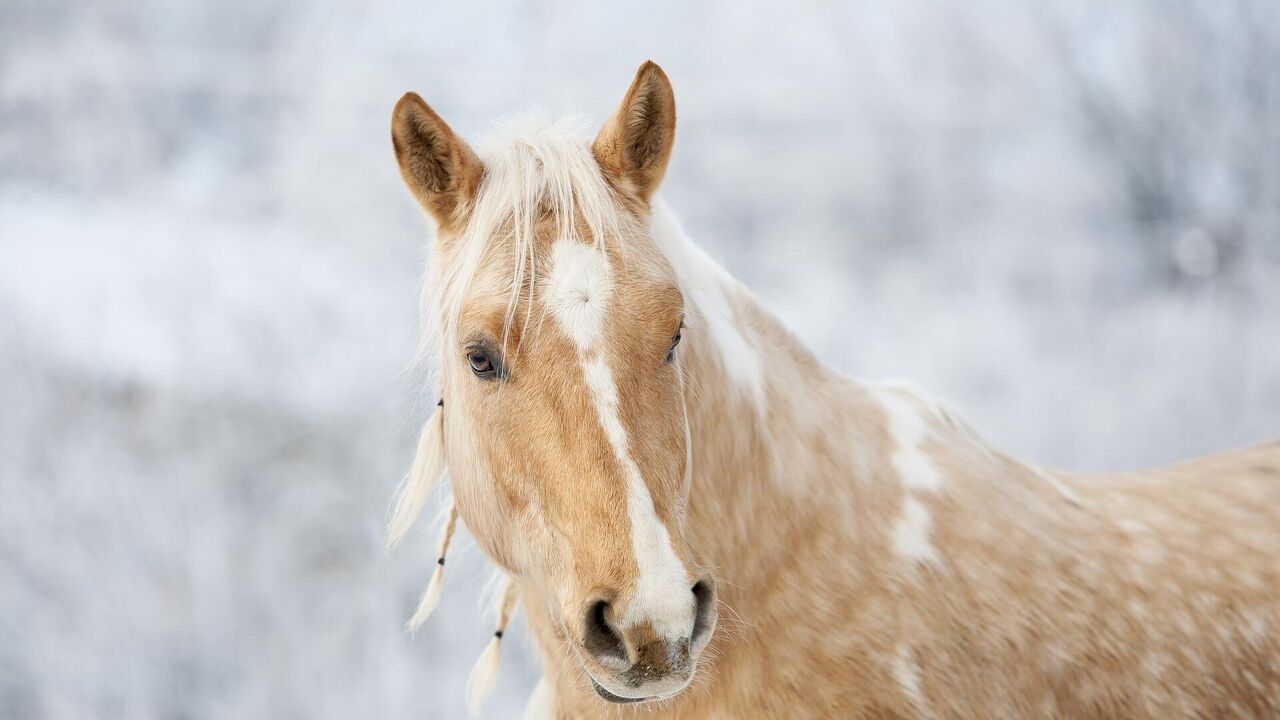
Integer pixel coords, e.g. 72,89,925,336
591,60,676,201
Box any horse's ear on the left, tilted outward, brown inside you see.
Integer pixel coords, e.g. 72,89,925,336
392,92,484,228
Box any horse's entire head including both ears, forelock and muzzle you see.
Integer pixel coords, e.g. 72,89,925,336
393,64,716,702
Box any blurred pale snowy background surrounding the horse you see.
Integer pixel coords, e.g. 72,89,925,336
0,0,1280,719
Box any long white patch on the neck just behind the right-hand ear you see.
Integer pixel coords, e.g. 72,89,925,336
649,199,765,414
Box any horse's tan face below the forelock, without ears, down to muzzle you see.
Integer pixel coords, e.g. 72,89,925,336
444,228,714,697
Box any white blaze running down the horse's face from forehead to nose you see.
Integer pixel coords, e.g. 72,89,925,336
547,240,694,637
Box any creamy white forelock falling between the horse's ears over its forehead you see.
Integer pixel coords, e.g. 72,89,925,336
422,109,632,354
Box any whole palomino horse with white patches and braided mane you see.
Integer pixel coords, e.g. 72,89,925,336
392,63,1280,719
